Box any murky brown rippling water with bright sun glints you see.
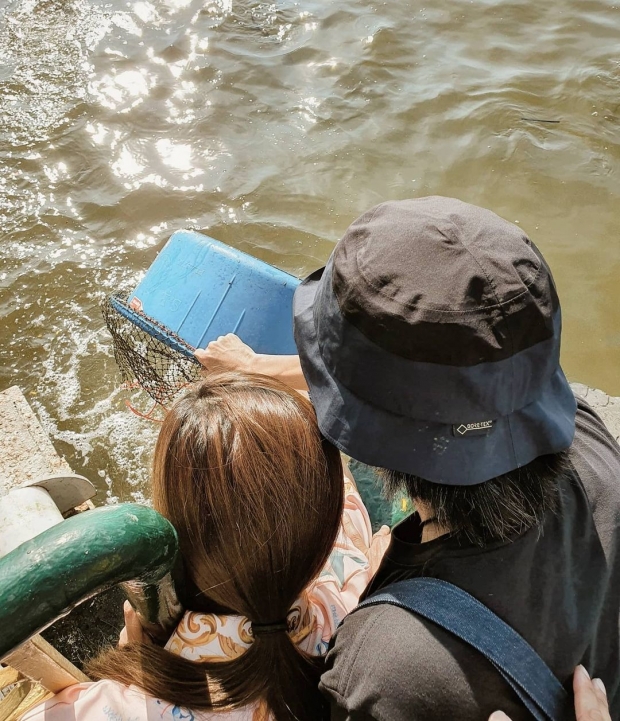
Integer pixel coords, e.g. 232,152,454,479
0,0,620,502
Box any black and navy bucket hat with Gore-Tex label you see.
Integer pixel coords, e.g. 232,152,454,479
294,197,576,485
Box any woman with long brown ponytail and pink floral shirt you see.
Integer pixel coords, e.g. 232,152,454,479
24,373,383,721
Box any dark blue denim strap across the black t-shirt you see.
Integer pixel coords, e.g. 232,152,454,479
355,578,574,721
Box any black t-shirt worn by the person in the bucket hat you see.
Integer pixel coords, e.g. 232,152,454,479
321,401,620,721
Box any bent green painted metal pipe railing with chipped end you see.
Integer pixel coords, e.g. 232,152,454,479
0,503,182,659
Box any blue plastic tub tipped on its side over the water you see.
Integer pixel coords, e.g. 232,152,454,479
114,230,300,355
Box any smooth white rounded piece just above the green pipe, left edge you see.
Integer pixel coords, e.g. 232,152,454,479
0,486,63,558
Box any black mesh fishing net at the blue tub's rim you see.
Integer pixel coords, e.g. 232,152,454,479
101,293,201,406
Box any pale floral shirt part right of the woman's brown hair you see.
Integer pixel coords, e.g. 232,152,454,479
299,477,388,656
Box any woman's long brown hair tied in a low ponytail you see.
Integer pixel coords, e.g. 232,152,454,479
87,373,344,721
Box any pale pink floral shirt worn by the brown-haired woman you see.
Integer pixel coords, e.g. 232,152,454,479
22,479,382,721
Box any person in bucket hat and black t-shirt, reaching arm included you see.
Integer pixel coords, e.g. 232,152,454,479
198,197,620,721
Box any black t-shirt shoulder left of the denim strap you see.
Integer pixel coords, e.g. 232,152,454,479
321,604,523,721
